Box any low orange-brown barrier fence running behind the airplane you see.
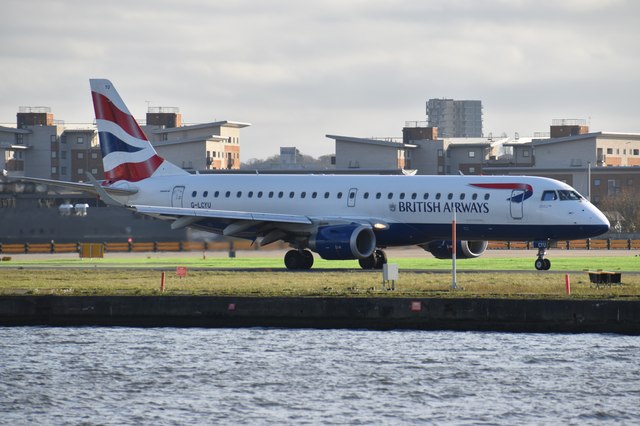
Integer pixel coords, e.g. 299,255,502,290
0,238,640,255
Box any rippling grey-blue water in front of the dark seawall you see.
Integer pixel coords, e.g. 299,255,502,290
0,327,640,425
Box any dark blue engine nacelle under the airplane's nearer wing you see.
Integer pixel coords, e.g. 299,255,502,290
309,224,376,260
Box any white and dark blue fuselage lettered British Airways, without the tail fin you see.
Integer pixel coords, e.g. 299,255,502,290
114,175,609,246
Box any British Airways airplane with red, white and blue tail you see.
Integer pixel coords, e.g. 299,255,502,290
6,79,609,270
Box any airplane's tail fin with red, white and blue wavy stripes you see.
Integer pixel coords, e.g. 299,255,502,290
89,79,188,182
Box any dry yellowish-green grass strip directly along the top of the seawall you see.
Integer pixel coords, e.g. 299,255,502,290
0,268,640,300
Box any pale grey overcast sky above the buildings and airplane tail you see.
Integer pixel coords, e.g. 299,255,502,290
0,0,640,161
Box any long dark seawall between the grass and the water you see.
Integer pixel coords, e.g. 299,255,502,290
0,296,640,334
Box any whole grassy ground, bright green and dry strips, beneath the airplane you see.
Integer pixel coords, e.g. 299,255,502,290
0,255,640,300
